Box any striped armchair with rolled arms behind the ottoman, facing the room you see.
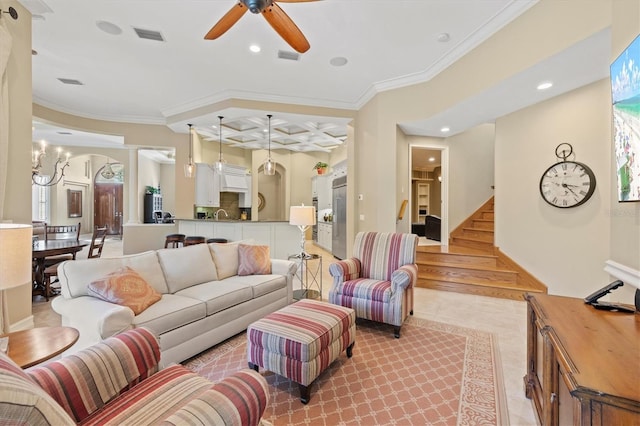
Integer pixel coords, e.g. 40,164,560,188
329,232,418,338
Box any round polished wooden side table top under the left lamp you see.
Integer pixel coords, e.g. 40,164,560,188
0,327,80,368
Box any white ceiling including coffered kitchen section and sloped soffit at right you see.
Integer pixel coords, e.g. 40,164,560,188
19,0,610,156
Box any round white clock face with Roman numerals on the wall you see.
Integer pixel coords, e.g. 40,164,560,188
540,161,596,208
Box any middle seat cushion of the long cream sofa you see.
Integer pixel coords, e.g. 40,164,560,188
176,278,253,315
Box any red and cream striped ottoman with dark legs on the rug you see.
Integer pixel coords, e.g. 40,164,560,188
247,299,356,404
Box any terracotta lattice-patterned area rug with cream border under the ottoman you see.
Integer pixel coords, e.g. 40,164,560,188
184,317,509,426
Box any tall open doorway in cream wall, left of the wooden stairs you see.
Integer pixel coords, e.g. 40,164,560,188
409,145,449,245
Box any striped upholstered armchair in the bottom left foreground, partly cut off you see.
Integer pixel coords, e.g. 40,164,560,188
0,328,268,426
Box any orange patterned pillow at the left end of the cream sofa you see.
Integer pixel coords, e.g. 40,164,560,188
87,266,162,315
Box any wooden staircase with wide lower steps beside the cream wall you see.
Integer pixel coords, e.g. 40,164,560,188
417,197,547,300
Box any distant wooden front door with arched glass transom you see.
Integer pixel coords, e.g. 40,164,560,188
93,163,124,236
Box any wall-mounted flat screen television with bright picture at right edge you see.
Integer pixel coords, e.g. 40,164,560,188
610,35,640,202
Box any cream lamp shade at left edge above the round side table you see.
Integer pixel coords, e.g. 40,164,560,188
0,223,33,290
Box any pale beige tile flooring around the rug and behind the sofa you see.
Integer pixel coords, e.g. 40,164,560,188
33,237,537,426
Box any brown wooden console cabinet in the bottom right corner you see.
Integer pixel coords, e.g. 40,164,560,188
524,294,640,426
